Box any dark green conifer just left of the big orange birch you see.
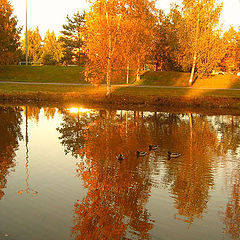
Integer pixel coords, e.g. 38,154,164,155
60,12,86,65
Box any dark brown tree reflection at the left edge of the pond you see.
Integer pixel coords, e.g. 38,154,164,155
0,106,22,199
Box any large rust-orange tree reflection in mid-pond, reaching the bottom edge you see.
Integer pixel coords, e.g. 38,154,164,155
72,111,156,239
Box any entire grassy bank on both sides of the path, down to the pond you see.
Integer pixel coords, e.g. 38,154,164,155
0,66,240,109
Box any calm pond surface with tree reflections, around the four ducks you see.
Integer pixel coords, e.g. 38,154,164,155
0,105,240,240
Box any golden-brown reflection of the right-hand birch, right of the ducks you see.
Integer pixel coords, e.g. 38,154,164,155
161,117,217,223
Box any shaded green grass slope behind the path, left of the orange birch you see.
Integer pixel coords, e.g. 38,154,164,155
0,66,86,84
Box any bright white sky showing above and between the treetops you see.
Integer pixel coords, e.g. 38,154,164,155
9,0,240,37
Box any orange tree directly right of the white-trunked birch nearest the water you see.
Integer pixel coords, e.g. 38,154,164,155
116,0,156,81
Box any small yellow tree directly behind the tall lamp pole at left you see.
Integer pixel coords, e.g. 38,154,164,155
22,27,42,62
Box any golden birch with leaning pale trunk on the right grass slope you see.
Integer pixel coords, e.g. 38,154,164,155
181,0,222,85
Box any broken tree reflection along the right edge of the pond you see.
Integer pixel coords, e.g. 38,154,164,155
214,116,240,240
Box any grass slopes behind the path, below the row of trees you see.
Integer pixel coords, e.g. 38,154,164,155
0,66,240,88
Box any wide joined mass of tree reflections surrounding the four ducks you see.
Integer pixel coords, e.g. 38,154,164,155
58,108,239,236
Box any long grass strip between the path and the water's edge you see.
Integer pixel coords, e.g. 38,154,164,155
0,84,240,109
